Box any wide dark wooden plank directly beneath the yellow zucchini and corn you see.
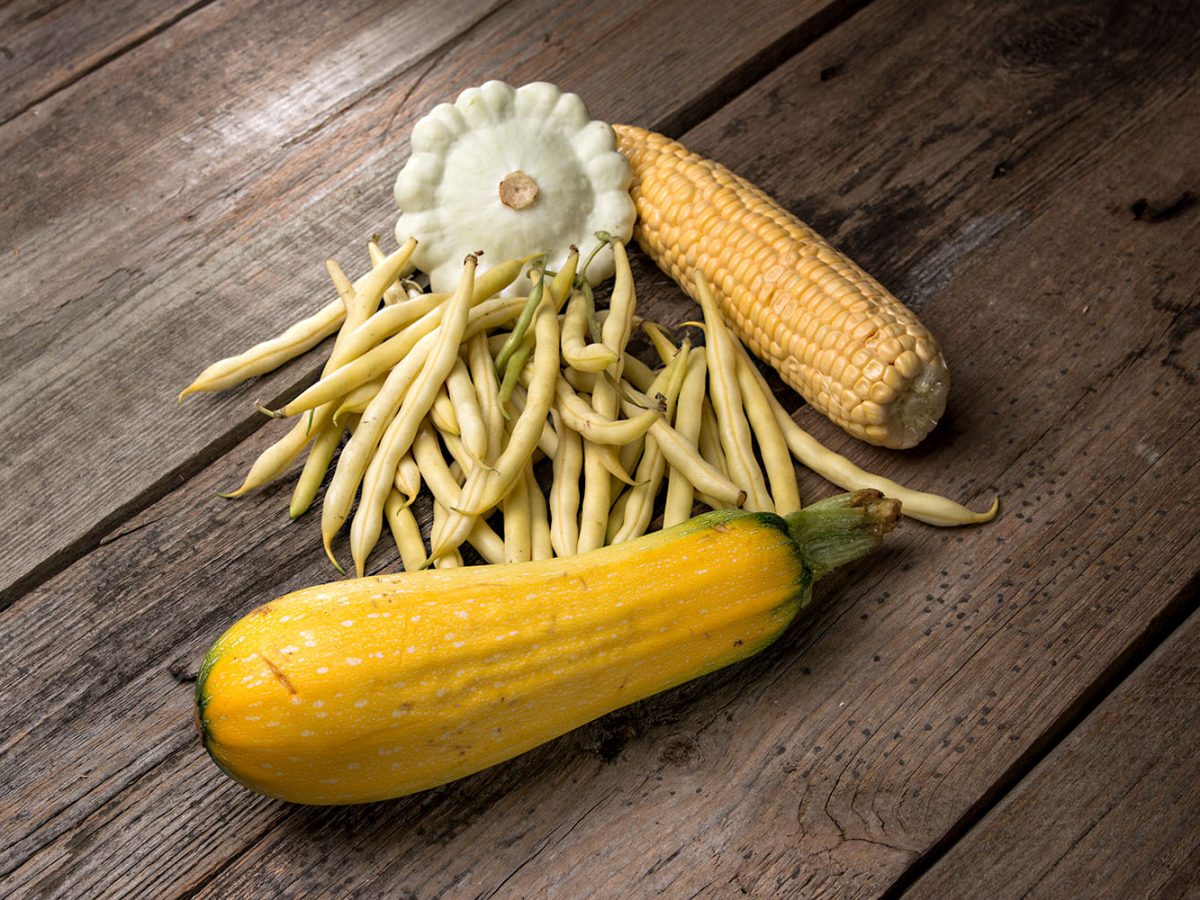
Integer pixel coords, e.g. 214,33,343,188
0,1,1200,896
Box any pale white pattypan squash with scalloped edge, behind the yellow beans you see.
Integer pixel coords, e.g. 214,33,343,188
396,82,636,293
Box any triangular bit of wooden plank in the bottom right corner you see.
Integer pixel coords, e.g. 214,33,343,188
906,613,1200,899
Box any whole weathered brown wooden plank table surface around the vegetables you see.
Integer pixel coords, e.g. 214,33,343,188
0,0,1200,899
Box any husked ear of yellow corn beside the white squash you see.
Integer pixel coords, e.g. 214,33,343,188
614,125,949,448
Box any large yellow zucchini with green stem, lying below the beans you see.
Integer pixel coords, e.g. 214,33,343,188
197,491,899,804
